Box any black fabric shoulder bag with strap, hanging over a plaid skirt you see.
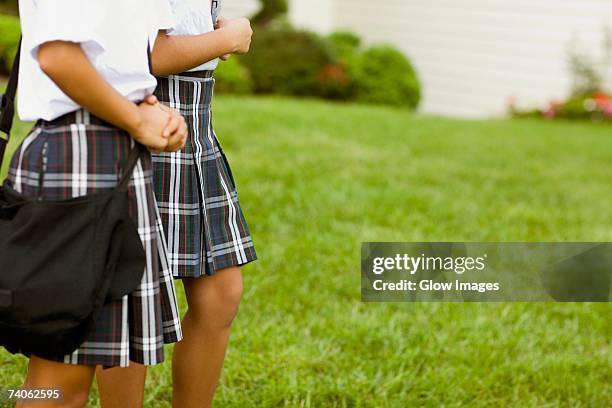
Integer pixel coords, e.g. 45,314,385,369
0,39,145,357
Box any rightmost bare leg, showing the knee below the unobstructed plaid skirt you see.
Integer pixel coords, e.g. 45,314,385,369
172,267,242,408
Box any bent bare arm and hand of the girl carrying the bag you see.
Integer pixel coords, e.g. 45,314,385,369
38,41,184,151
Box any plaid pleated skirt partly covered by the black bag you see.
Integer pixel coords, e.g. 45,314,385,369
7,110,182,367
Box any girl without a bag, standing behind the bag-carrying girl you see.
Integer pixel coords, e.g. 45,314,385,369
98,0,256,407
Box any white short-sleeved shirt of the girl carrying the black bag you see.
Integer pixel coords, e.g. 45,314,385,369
17,0,173,121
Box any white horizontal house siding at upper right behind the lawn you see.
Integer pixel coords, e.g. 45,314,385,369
226,0,612,117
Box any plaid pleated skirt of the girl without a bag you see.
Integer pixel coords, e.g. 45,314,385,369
153,71,257,278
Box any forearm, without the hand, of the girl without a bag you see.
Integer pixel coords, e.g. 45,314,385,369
151,29,235,75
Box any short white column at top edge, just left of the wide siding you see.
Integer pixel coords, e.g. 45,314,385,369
289,0,334,34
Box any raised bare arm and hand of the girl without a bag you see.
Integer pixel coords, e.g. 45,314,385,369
151,18,253,75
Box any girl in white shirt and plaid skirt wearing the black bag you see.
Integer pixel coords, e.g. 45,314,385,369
7,0,186,407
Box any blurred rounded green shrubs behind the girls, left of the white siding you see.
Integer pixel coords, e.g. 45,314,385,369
0,0,421,109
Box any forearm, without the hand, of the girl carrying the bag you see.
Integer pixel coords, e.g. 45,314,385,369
38,41,142,134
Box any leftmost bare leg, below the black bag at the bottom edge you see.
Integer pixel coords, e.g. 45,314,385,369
16,356,94,408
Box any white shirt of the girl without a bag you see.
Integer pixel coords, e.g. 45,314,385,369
168,0,221,71
